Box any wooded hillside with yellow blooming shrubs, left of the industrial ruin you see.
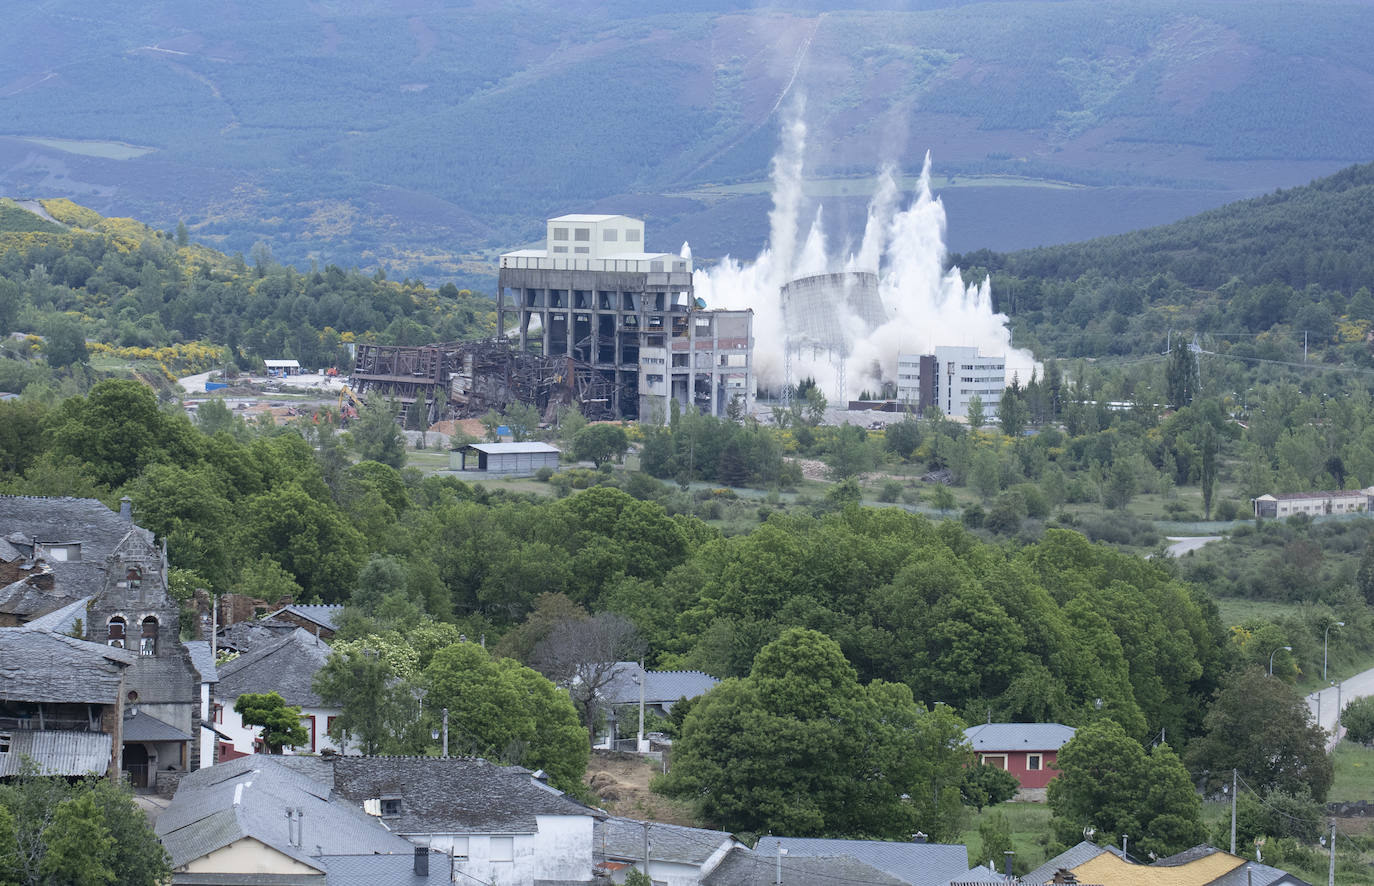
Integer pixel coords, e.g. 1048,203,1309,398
0,201,495,391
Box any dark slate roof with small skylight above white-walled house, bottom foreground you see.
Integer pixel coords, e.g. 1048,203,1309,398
334,757,598,834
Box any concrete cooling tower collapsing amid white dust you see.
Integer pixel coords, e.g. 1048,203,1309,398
782,271,888,357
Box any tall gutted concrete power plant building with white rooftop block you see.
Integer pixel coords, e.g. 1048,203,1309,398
496,216,757,419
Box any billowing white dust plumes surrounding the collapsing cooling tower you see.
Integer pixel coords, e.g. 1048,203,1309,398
692,100,1035,398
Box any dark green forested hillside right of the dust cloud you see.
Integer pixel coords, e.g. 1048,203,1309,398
952,158,1374,359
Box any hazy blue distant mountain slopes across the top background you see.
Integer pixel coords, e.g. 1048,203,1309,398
0,0,1374,279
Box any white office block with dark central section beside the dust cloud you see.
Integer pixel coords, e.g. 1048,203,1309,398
897,346,1007,419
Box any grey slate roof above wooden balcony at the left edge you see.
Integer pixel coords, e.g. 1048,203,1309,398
0,628,136,705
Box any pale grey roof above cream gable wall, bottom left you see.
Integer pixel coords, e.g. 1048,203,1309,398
154,754,412,871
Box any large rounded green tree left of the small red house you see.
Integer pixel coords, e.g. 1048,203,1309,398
655,628,967,839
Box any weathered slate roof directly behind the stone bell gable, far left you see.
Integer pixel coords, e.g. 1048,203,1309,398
0,496,153,599
